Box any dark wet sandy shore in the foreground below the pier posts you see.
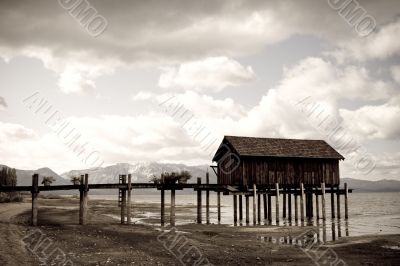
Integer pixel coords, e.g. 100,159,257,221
0,199,400,265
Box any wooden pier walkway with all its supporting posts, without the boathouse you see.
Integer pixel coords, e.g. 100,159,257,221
0,174,352,226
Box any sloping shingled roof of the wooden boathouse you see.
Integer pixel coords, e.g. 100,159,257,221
213,136,344,161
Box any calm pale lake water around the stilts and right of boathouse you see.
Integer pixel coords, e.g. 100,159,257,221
91,192,400,242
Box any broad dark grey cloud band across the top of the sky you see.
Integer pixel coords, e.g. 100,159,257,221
0,0,399,63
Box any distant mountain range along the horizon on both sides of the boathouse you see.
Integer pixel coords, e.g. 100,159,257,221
0,162,400,192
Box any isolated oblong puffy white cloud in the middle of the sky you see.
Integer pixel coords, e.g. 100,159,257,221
158,57,255,92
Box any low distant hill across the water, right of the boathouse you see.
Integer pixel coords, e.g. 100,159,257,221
340,178,400,192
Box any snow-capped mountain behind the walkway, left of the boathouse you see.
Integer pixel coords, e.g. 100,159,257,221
61,162,216,184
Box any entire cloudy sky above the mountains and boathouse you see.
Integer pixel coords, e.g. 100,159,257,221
0,0,400,180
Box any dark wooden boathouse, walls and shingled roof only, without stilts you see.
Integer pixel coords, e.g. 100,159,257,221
213,136,344,188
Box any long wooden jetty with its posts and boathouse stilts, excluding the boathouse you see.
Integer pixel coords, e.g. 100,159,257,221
0,174,352,226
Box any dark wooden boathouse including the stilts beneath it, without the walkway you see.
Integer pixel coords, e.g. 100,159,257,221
212,136,348,222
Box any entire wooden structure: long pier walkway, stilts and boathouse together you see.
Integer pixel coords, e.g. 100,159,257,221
0,137,352,226
